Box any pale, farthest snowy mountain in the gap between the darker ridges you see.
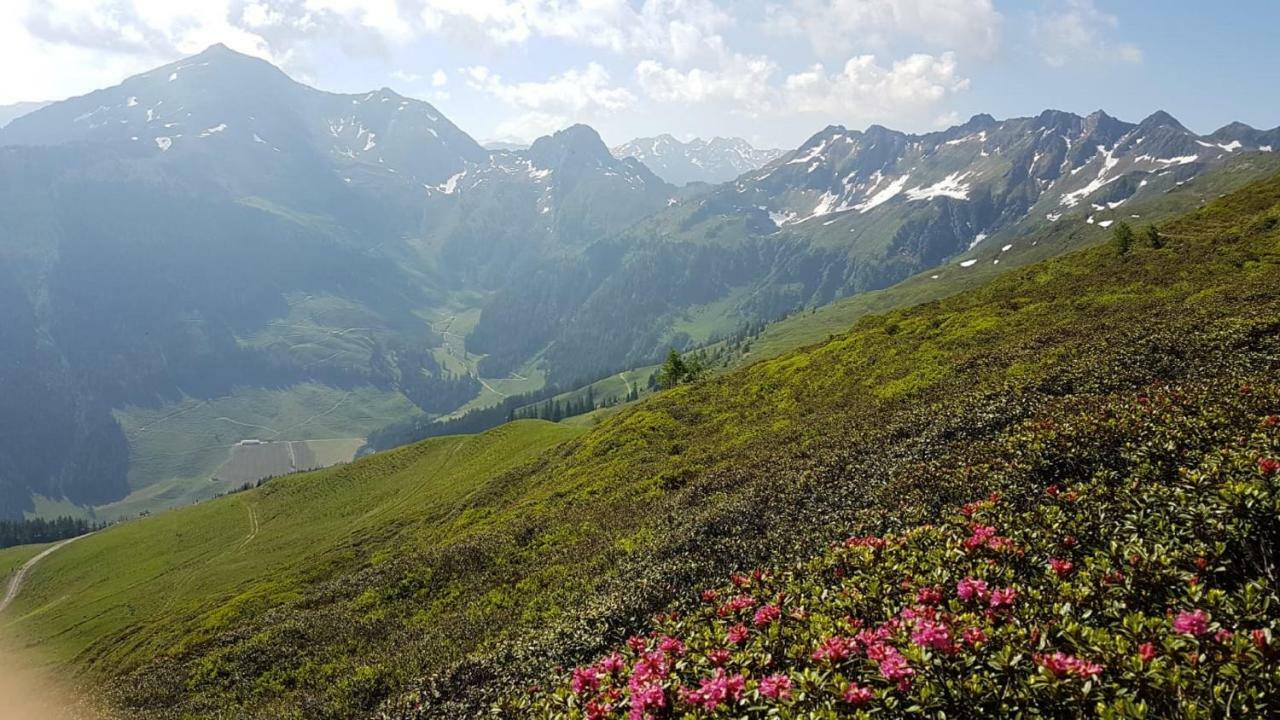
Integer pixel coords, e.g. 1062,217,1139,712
613,135,783,184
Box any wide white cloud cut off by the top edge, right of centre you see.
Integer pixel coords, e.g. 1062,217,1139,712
765,0,1002,58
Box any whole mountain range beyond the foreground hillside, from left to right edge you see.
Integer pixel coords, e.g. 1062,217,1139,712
0,46,1280,516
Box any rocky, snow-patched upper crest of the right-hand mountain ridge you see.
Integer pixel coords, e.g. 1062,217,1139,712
721,110,1280,237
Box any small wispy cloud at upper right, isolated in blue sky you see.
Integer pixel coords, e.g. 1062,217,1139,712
1032,0,1142,68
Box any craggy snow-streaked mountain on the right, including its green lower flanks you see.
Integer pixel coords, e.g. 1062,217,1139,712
477,110,1280,382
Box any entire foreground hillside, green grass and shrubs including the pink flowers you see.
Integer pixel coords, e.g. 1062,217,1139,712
10,169,1280,720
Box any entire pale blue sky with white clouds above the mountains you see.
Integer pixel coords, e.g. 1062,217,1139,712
0,0,1280,149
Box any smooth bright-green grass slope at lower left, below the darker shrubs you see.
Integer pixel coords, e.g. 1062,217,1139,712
3,421,576,671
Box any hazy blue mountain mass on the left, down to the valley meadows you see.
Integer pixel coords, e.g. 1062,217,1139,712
0,45,673,518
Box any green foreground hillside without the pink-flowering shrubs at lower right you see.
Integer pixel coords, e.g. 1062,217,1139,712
8,170,1280,717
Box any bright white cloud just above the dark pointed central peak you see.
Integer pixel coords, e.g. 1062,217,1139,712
461,63,636,141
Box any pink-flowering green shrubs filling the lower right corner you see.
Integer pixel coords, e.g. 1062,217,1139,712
504,398,1280,720
